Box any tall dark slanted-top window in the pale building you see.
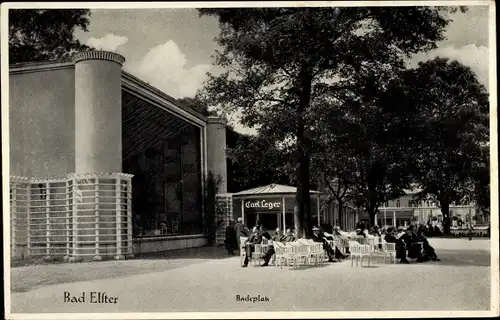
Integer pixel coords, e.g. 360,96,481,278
122,93,203,236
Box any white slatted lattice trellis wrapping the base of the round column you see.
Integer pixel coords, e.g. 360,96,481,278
10,173,132,261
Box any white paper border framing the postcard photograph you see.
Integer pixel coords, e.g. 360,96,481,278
0,0,500,319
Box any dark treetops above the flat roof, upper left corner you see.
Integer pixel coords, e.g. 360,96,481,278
9,9,90,63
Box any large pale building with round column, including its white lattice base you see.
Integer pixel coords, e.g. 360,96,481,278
9,51,227,258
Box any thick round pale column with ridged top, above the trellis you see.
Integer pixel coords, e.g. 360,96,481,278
73,51,125,173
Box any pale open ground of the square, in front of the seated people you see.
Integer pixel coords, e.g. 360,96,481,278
11,239,491,313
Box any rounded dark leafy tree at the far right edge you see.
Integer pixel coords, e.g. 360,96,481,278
402,57,489,234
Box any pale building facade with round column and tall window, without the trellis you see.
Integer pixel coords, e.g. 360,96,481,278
9,51,227,253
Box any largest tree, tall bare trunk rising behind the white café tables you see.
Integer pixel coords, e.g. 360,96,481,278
199,7,455,236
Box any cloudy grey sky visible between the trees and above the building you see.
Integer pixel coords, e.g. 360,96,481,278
76,6,489,133
